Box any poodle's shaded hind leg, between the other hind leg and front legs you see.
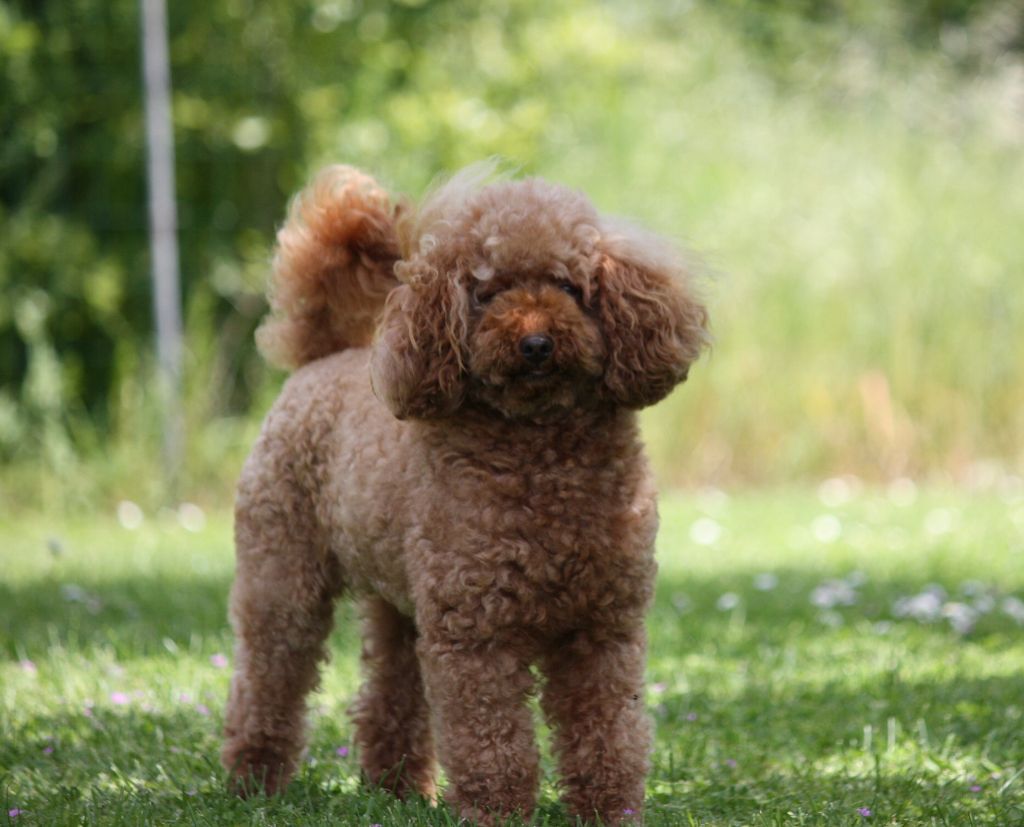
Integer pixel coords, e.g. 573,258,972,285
351,598,436,798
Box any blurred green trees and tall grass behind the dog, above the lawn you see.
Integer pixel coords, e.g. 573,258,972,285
0,0,1024,510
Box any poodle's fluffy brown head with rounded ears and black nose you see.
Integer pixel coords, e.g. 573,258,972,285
371,170,708,419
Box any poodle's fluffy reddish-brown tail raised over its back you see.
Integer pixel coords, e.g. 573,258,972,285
256,166,399,368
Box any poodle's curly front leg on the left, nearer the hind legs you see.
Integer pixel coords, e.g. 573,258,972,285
419,633,538,825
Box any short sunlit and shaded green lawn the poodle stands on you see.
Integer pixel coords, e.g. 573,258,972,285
0,482,1024,825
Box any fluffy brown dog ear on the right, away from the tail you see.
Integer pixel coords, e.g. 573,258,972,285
598,224,710,408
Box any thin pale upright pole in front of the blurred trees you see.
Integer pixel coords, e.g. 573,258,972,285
140,0,184,495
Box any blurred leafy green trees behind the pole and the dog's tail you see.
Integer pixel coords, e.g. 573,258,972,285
0,0,1024,468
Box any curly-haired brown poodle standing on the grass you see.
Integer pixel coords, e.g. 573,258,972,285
222,167,707,824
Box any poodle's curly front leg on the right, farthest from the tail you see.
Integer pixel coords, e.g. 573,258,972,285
541,626,651,825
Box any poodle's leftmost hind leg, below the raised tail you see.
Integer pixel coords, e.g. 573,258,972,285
221,489,341,795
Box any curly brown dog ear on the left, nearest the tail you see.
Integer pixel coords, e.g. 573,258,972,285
370,261,468,420
